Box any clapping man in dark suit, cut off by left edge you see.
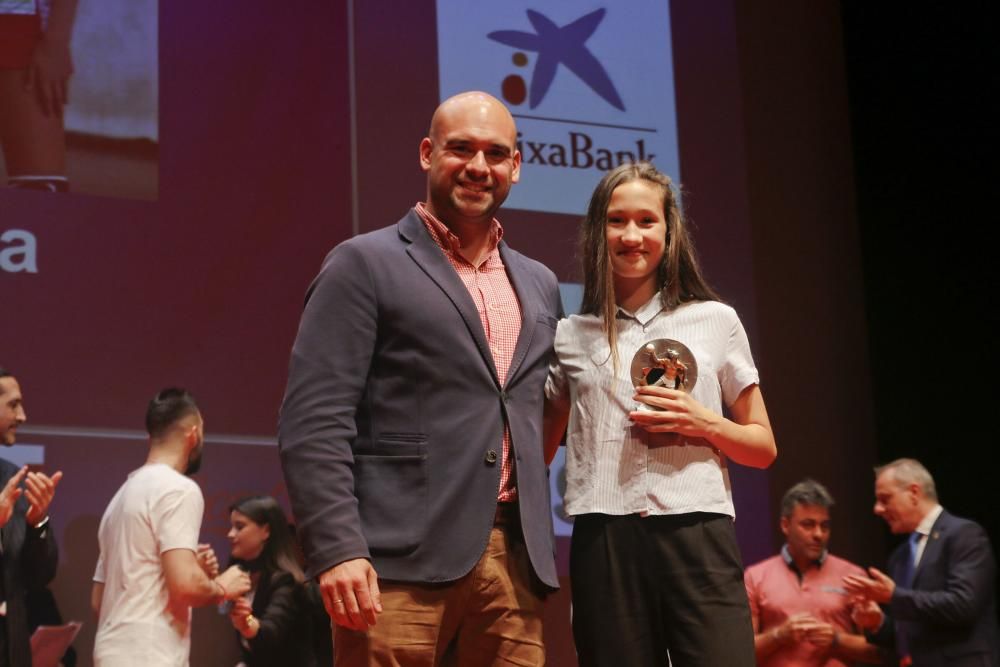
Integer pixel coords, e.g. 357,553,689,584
0,367,62,667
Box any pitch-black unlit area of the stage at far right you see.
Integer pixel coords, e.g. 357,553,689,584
841,1,1000,604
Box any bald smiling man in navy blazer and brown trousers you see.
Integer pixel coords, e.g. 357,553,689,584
279,92,561,666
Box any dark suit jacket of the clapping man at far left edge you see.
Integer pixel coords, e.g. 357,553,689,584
0,459,59,667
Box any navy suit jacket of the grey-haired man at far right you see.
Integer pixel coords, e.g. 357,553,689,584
881,511,1000,667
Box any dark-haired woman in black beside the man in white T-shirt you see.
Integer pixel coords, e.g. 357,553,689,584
228,496,314,667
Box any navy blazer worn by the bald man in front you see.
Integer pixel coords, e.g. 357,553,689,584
278,210,562,588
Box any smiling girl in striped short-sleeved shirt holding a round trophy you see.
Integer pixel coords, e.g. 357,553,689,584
546,162,777,667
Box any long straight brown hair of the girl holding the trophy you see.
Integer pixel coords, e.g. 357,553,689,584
580,162,722,369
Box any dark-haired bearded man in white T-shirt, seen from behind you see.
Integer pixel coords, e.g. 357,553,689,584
91,389,250,667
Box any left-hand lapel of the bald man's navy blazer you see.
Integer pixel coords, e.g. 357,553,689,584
399,211,510,387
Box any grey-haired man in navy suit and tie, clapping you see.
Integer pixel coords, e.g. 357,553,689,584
844,459,1000,667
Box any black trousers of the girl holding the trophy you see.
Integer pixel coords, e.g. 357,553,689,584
570,513,756,667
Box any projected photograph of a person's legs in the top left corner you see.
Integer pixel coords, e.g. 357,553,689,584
0,0,159,200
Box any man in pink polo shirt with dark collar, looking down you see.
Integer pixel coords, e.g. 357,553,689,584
743,479,881,667
